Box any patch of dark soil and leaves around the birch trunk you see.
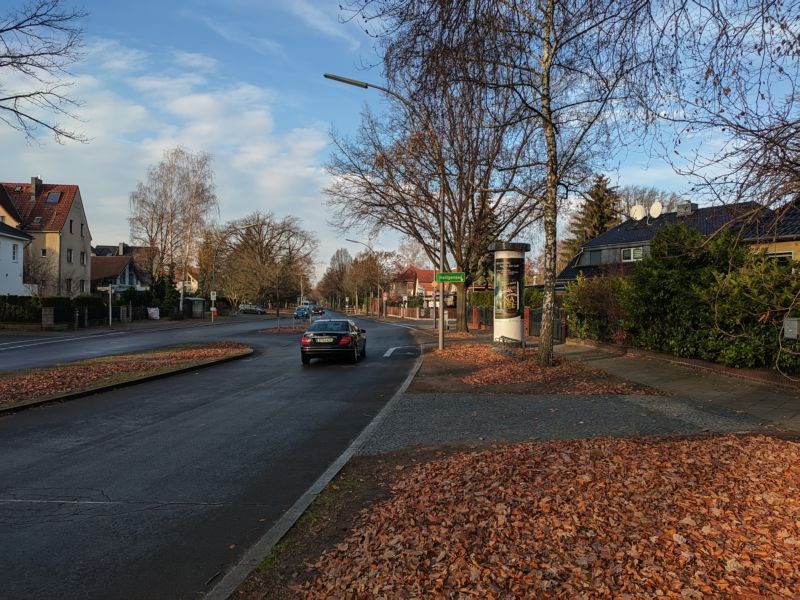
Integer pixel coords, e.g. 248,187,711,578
409,342,663,395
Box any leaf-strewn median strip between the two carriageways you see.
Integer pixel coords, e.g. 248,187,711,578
0,342,250,408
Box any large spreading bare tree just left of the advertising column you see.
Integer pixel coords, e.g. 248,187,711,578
326,61,538,330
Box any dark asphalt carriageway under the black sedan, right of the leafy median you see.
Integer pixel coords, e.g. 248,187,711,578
0,314,417,600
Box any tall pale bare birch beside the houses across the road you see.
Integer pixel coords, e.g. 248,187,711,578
128,147,218,308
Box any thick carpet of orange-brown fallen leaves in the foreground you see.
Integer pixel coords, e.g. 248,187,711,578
297,436,800,599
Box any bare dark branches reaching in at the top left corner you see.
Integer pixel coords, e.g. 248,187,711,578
0,0,87,143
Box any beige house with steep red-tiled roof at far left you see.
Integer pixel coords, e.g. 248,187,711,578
0,177,92,296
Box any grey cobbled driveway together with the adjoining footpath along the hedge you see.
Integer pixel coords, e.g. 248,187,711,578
357,331,800,455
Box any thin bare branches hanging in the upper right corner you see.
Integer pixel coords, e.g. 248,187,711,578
646,0,800,213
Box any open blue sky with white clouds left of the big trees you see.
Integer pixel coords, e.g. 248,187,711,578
0,0,680,274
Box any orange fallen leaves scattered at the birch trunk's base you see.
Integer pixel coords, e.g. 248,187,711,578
434,343,655,395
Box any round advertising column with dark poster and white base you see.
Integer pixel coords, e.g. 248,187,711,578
489,242,531,343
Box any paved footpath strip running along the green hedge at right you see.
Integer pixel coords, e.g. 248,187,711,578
555,342,800,433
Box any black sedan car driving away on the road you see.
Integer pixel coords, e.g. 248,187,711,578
300,319,367,365
